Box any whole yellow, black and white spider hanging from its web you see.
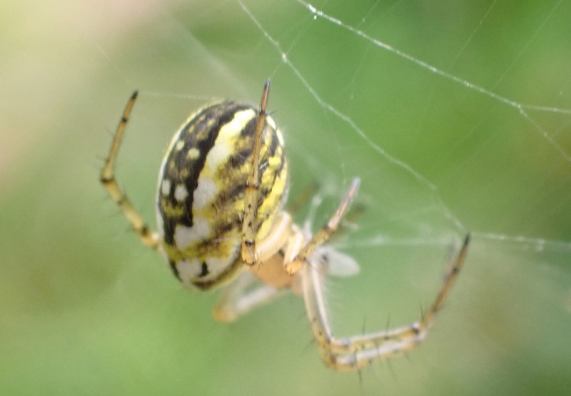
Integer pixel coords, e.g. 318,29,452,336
100,81,470,371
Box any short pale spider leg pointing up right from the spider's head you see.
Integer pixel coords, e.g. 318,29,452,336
285,177,361,274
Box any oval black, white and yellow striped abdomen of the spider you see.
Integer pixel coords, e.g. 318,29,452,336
157,101,287,288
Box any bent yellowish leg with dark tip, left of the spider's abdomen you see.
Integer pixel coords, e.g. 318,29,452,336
99,91,159,249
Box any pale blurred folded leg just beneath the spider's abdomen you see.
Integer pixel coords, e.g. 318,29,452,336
213,272,284,322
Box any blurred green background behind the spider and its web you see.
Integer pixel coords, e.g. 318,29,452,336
0,0,571,395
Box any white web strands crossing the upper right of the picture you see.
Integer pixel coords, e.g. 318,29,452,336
242,0,571,251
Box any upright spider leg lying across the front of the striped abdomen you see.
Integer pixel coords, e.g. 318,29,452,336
241,80,270,266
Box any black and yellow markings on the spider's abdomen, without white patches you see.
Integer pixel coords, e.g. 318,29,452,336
158,101,287,288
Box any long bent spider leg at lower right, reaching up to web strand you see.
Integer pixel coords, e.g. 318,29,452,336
301,235,470,371
